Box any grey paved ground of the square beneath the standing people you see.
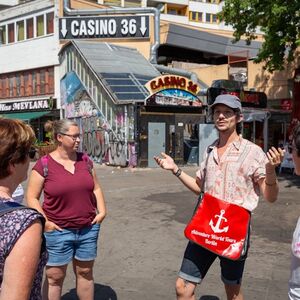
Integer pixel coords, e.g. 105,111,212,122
24,165,300,300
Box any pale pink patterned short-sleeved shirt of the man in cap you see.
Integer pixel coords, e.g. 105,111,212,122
197,137,268,211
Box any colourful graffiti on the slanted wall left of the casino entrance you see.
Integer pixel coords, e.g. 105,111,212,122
61,72,137,167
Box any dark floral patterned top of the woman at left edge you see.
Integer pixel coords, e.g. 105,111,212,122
0,198,48,300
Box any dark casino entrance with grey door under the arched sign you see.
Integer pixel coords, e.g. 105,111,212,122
137,107,204,167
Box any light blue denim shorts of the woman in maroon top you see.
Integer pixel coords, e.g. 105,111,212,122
44,224,100,266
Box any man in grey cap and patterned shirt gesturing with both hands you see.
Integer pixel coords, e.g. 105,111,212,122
154,95,284,300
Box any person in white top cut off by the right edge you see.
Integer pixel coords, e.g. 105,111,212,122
288,125,300,300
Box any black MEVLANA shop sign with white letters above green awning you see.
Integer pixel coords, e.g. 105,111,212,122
0,98,54,112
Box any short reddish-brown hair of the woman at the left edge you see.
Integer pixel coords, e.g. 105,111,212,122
0,118,35,179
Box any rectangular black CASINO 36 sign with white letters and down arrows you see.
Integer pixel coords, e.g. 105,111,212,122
59,16,149,40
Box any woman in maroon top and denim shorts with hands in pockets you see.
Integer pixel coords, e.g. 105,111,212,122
27,120,106,300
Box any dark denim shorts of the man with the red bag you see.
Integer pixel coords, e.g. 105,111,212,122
178,242,245,284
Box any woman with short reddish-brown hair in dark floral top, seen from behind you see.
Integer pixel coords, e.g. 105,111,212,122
0,118,47,300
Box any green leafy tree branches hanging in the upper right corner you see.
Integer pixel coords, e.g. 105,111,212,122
219,0,300,72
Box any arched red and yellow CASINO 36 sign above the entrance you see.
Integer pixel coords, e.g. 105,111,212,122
146,75,200,95
